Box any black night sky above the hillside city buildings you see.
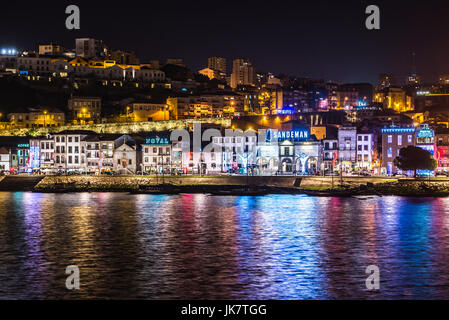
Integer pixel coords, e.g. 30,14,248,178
0,0,449,84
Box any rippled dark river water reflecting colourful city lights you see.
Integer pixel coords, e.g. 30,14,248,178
0,192,449,299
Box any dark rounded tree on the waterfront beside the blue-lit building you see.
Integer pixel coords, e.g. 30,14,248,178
394,146,437,177
